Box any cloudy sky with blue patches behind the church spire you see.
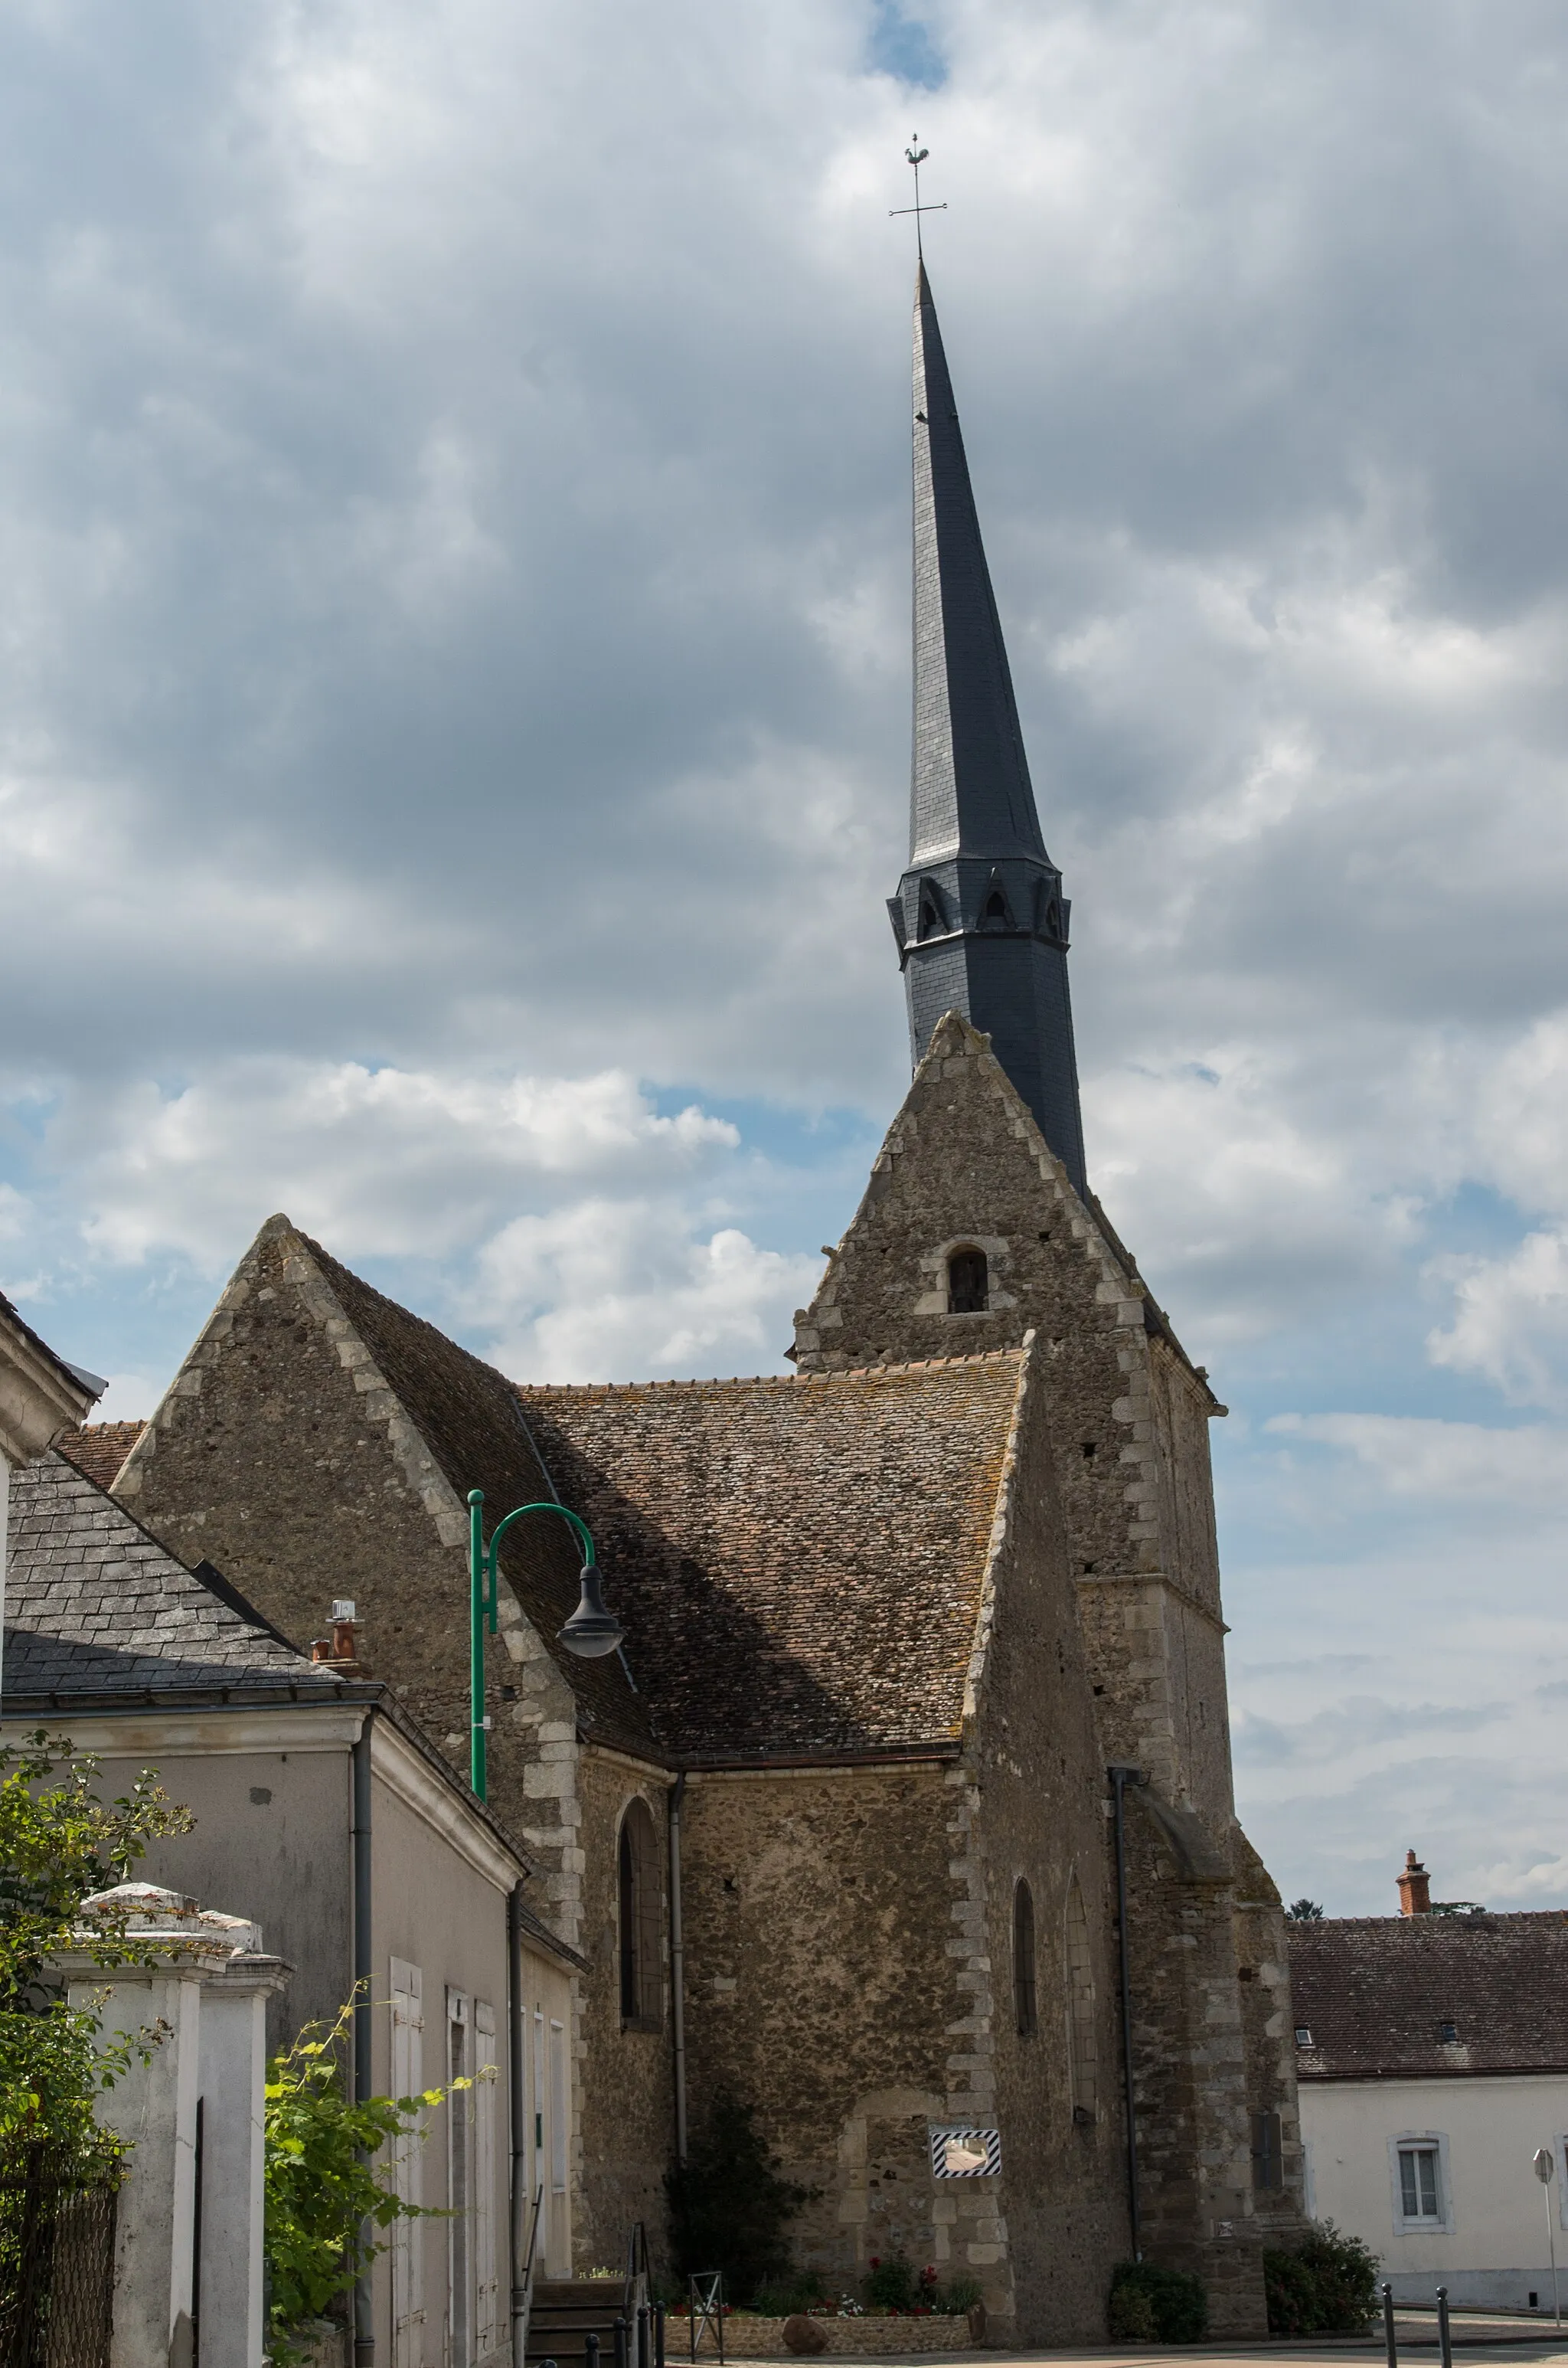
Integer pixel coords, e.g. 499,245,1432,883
0,0,1568,1913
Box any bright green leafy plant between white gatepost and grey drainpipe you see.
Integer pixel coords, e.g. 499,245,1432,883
263,2001,474,2363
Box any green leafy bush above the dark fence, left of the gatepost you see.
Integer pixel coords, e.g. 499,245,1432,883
0,1729,194,2160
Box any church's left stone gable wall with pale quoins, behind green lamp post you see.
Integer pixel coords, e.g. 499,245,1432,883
116,1219,599,2245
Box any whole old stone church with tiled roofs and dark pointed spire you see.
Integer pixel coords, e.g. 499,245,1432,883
92,265,1300,2342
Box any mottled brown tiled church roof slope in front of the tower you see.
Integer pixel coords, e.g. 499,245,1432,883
521,1349,1023,1757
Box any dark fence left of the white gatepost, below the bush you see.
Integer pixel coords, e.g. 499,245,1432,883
0,2141,121,2368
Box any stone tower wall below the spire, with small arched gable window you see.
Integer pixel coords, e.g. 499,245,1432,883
795,1016,1293,2333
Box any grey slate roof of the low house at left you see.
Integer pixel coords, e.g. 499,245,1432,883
0,1451,336,1707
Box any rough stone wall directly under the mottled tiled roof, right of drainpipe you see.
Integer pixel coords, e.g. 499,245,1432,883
682,1761,990,2318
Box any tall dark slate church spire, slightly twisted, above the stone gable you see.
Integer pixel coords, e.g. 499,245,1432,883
888,260,1087,1193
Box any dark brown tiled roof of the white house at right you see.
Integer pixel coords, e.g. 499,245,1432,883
1286,1908,1568,2079
